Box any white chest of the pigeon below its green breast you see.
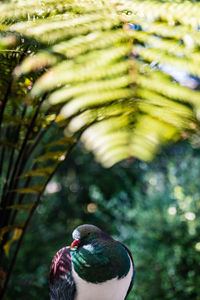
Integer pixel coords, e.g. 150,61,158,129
72,255,133,300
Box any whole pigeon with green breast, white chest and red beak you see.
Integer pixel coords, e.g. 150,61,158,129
49,224,135,300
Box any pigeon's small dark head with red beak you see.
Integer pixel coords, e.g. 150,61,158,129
71,224,108,250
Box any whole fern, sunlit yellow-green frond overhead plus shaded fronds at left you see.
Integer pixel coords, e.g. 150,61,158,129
0,0,200,297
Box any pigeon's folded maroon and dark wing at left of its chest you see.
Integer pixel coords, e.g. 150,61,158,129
49,247,76,300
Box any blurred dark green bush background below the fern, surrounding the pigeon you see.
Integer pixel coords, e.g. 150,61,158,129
7,143,200,300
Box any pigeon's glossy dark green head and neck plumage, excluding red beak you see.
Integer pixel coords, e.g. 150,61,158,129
71,225,130,283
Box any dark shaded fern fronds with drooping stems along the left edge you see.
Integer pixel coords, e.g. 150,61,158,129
0,21,75,298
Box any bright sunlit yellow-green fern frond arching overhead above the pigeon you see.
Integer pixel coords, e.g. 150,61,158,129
1,0,200,166
